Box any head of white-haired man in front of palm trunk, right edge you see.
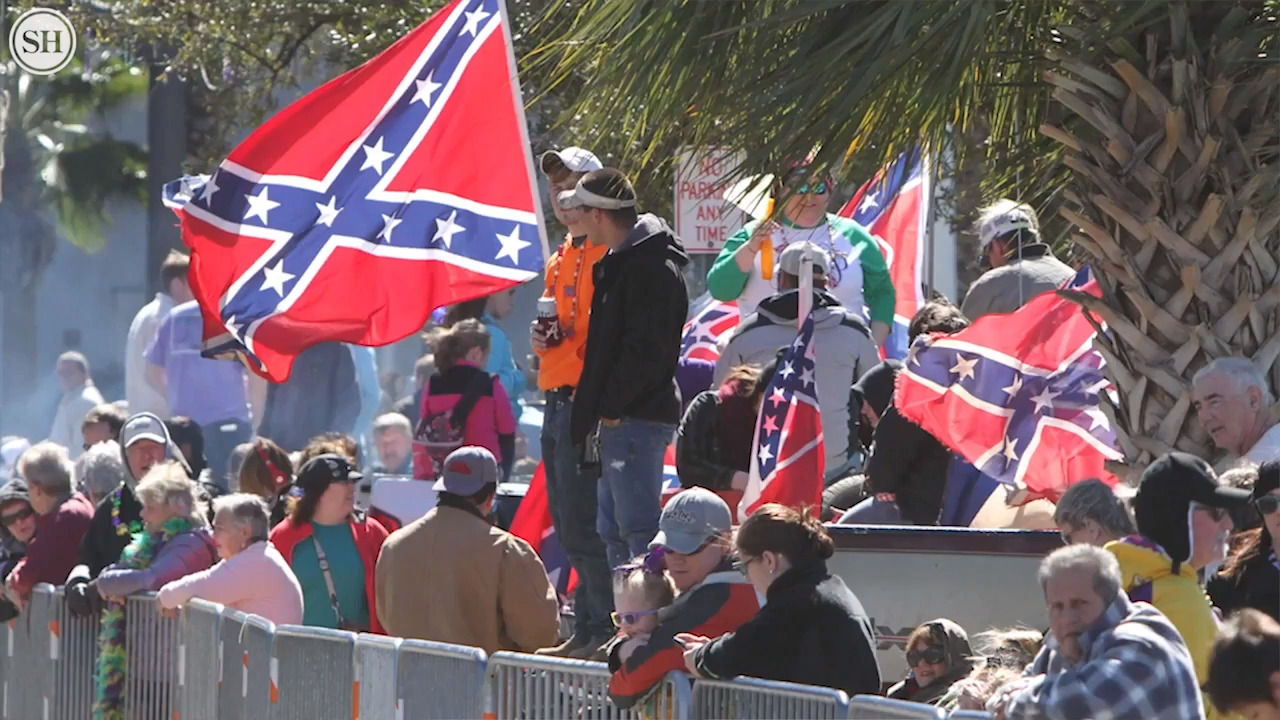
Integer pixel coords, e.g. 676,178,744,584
1192,357,1280,465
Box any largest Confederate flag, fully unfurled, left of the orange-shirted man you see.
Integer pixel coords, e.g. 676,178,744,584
165,0,545,382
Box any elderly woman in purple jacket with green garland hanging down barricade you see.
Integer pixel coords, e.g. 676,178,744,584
93,462,218,720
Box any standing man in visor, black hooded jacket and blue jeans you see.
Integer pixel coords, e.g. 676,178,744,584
559,168,689,568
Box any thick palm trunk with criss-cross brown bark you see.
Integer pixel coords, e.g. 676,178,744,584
1041,3,1280,480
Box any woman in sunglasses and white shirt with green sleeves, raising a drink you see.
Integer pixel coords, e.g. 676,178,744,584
707,161,896,345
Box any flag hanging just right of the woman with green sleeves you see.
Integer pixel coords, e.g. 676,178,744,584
838,150,932,360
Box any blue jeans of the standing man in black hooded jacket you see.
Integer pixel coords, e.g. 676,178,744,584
595,418,676,568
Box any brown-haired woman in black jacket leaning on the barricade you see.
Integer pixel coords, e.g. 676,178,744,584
676,503,881,696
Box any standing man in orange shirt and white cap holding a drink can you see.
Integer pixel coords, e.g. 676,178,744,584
529,147,613,657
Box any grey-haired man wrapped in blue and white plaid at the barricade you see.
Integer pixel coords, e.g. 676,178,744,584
987,544,1204,720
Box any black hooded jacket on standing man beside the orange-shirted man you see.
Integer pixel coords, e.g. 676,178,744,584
571,214,689,446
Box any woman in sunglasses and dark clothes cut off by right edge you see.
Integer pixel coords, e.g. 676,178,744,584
1208,462,1280,620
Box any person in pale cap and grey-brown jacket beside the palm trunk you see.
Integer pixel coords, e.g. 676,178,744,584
960,200,1075,320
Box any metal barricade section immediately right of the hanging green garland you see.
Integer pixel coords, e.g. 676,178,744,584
124,592,180,720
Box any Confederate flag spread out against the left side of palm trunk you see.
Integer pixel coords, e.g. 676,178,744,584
895,268,1121,502
